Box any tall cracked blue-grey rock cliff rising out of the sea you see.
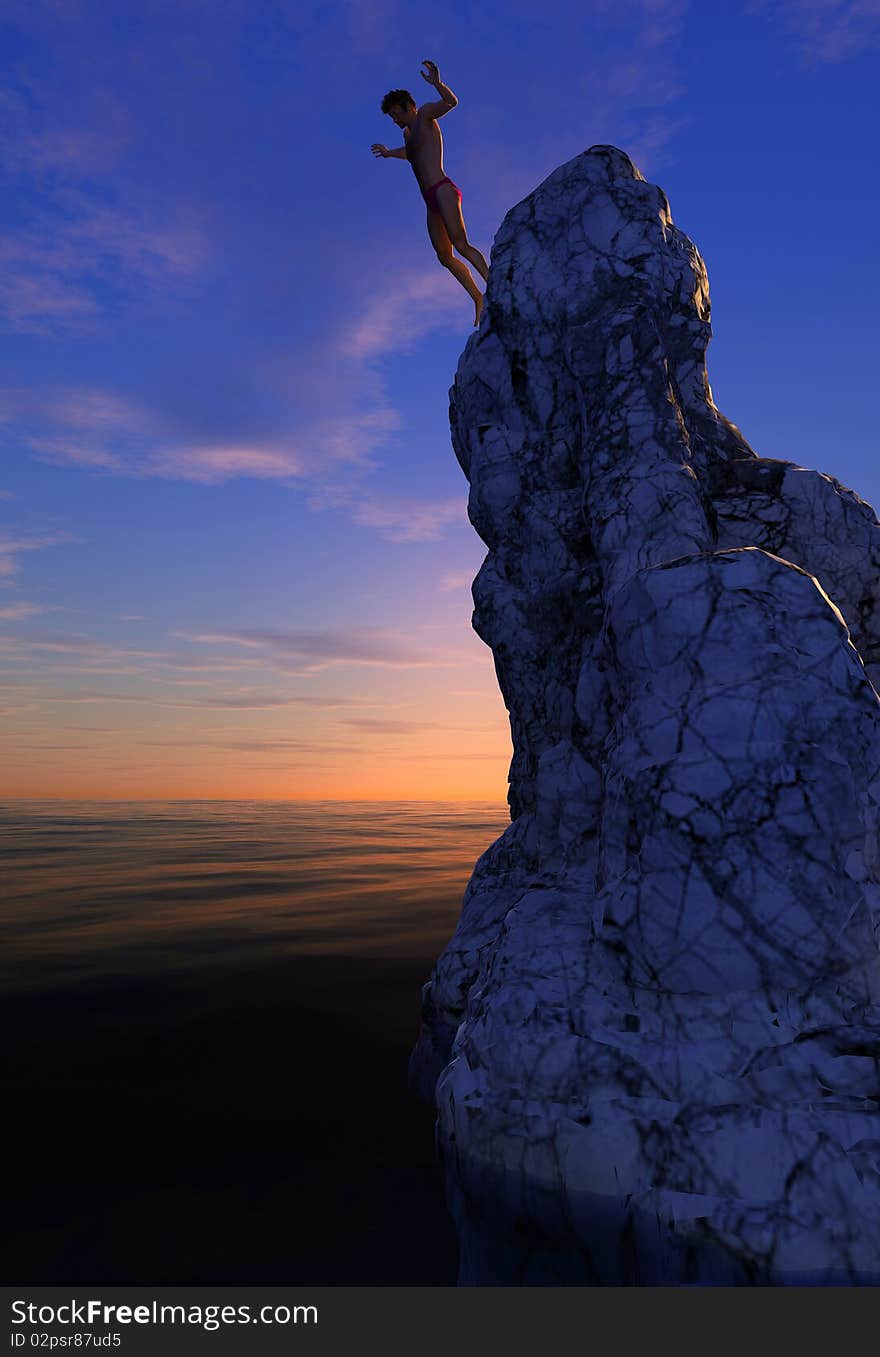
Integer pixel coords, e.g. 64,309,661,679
410,147,880,1285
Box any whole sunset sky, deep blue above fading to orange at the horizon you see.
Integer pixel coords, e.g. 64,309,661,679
0,0,880,803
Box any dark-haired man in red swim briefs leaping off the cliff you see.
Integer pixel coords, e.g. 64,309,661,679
371,61,489,326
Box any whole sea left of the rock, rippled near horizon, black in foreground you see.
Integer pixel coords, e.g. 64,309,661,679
0,801,508,1285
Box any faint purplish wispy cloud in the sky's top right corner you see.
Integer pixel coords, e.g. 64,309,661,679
750,0,880,66
